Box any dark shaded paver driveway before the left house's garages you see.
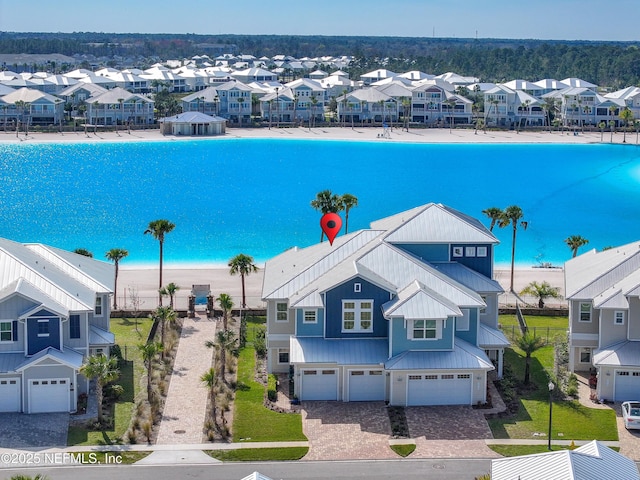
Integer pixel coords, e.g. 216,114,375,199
0,413,69,448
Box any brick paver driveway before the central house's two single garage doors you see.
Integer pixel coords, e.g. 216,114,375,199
302,402,398,460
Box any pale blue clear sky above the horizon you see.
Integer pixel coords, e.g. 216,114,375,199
0,0,640,41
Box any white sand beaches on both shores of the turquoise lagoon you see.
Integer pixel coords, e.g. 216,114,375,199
0,126,580,310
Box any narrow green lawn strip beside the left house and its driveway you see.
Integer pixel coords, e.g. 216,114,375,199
67,318,152,445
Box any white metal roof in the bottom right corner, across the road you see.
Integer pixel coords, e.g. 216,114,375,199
491,440,640,480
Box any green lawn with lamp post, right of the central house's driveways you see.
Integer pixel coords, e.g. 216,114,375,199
489,345,618,440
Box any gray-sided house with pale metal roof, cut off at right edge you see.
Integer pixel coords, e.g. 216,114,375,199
565,242,640,401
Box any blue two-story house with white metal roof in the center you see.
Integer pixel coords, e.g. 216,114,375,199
263,203,509,405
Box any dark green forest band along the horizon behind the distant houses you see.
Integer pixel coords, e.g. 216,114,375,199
0,32,640,88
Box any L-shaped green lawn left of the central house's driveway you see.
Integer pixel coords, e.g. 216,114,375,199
233,344,307,442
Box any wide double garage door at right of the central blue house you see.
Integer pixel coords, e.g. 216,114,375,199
407,373,471,405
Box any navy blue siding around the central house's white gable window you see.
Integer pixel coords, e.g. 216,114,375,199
325,278,391,338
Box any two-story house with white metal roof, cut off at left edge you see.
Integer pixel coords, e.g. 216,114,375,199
0,239,114,413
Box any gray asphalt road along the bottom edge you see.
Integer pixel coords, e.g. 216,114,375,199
0,459,491,480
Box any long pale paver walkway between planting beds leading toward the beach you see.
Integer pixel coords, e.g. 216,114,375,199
156,314,216,445
